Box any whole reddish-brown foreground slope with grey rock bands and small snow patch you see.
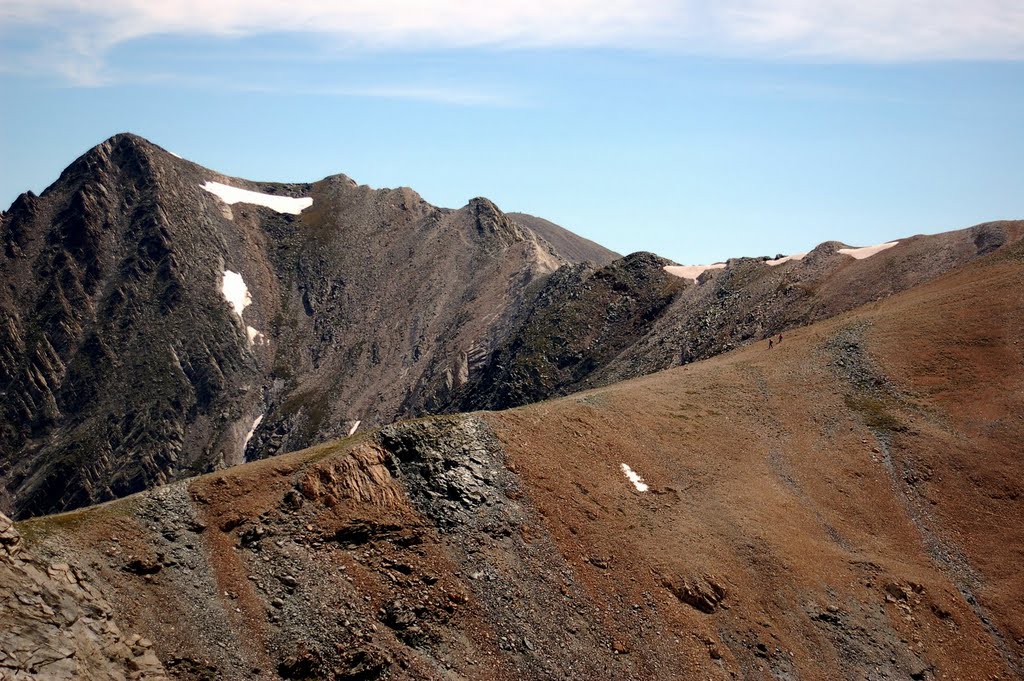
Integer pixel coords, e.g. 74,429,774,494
12,237,1024,679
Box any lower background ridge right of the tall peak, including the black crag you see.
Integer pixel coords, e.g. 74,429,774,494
447,220,1024,411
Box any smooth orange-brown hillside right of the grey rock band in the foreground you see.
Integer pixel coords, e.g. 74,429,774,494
487,241,1024,679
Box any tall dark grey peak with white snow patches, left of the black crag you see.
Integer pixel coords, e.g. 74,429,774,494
0,135,564,516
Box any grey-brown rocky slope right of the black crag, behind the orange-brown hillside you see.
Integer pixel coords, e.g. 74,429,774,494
598,220,1024,387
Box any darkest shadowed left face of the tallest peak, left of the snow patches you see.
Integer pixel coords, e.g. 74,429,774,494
0,136,250,515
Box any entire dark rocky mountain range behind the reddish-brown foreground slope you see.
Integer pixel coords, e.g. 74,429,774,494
0,134,1024,517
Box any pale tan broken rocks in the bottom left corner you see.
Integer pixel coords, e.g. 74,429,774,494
0,514,167,681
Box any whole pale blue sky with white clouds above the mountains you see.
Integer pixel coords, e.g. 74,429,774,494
0,0,1024,263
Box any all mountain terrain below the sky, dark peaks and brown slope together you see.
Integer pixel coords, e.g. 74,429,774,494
0,134,1024,680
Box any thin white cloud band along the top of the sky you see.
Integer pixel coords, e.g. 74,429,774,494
0,0,1024,83
